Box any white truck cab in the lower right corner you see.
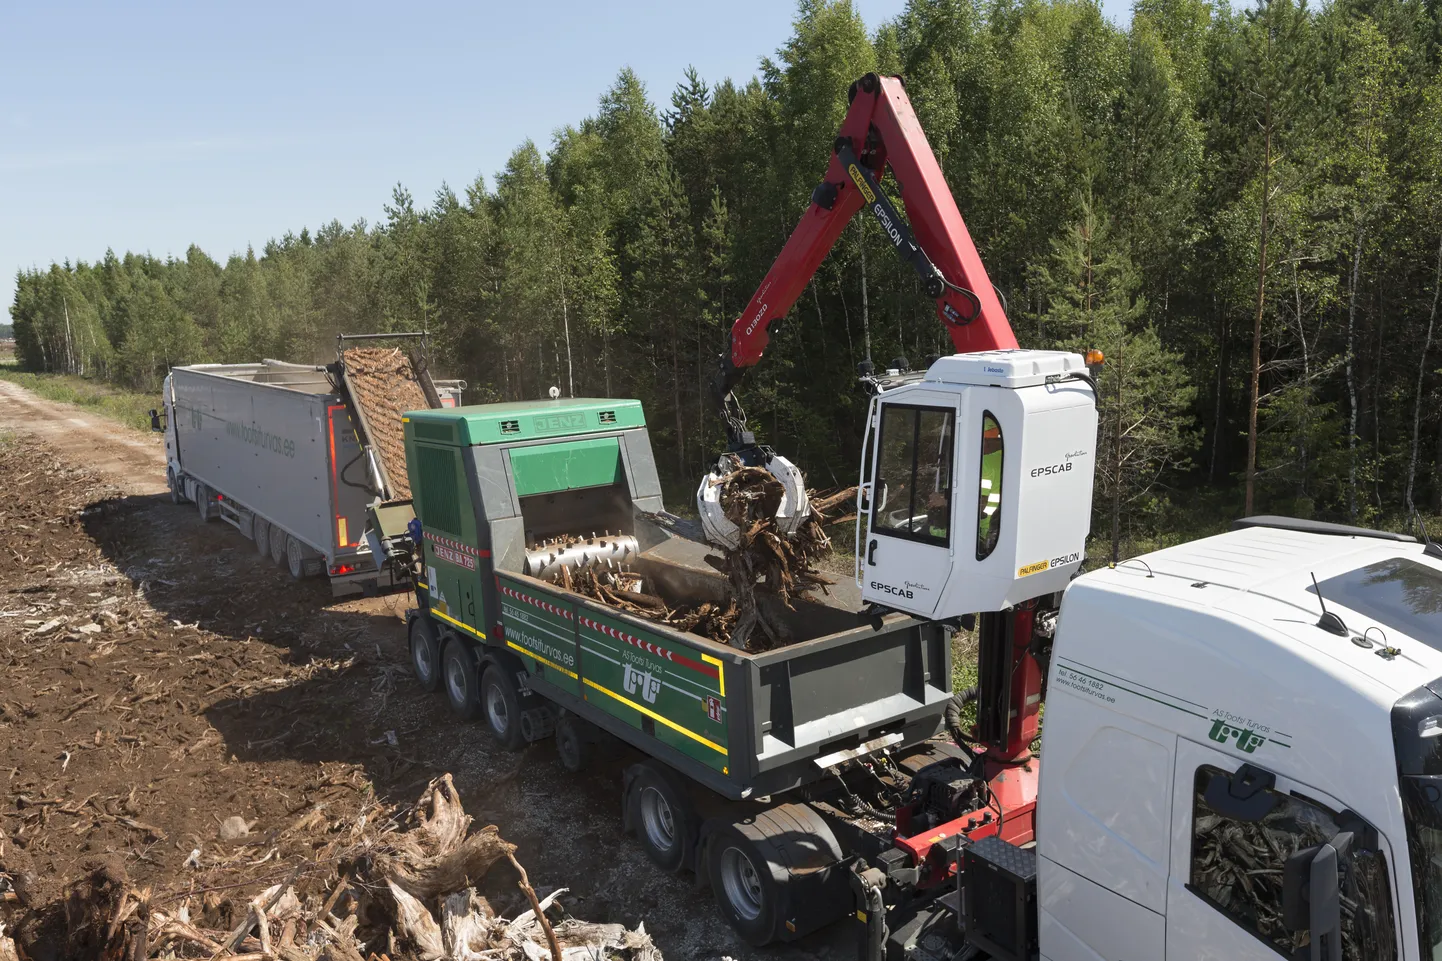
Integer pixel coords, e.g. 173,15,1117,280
1037,518,1442,961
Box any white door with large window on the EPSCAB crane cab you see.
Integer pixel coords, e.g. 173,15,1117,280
858,391,959,616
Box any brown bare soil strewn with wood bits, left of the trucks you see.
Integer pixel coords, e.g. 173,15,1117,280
0,382,851,958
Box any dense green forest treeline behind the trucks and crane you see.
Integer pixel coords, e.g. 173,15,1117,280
12,0,1442,534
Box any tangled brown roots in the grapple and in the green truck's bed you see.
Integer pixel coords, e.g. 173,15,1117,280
557,468,857,652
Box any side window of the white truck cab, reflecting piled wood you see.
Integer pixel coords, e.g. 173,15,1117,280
1187,761,1397,961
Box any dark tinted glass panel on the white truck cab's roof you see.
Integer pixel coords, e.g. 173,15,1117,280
1308,557,1442,649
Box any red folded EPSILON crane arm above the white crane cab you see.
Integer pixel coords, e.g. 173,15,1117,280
721,74,1017,380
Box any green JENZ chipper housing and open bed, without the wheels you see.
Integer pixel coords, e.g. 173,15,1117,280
405,400,952,799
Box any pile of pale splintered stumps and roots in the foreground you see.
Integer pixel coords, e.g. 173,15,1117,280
0,775,662,961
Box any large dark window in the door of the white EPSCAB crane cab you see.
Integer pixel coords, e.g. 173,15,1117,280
871,404,956,547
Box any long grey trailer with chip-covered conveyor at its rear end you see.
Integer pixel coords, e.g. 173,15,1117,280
165,333,464,594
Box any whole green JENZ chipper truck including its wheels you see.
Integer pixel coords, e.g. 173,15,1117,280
372,398,952,944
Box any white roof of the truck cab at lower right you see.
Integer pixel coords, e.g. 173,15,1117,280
1073,527,1442,695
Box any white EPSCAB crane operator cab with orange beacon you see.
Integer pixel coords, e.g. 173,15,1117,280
857,351,1096,619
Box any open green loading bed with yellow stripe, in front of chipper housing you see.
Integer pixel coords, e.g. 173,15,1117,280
496,538,952,799
